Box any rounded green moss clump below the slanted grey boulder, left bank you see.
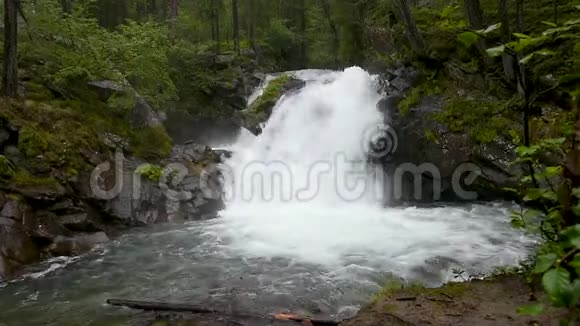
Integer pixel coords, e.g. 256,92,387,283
133,126,173,159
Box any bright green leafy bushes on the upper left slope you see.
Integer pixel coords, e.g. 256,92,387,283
22,0,175,107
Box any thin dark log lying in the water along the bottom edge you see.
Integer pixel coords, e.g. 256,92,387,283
107,299,340,326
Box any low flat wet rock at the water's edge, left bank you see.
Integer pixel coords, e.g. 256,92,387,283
48,232,109,256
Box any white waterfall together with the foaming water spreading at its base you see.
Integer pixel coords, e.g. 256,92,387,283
217,67,532,278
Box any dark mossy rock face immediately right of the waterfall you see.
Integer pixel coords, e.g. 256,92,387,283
379,68,521,203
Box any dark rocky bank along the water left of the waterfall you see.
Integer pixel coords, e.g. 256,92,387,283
0,118,223,280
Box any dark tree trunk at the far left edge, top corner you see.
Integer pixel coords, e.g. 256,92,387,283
2,0,19,97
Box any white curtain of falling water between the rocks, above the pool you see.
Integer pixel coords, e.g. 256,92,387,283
226,68,382,205
